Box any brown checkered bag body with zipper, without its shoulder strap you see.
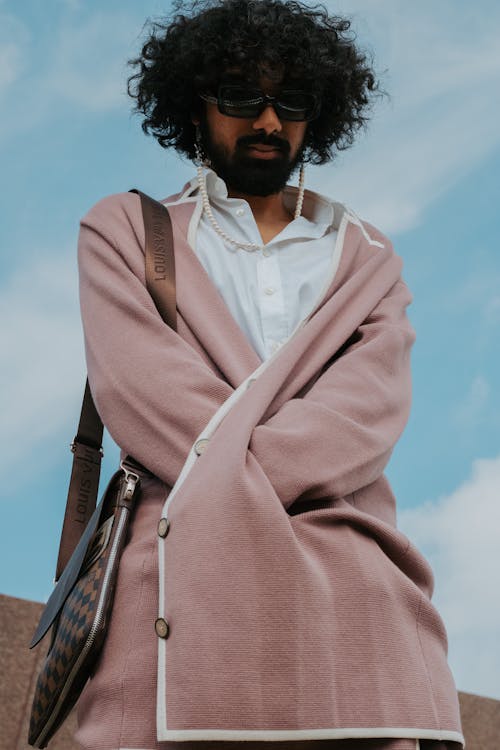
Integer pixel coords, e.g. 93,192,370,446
28,462,140,747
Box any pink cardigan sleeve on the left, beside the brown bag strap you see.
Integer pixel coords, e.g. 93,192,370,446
78,193,233,486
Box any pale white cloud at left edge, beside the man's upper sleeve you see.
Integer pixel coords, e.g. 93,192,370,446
0,252,86,482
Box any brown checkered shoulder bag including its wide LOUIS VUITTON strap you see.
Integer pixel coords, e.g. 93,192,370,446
28,190,176,748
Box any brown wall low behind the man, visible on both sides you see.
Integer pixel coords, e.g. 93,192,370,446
0,594,500,750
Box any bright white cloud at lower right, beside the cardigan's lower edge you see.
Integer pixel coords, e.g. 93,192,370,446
399,456,500,699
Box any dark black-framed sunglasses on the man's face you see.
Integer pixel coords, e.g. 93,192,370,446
200,84,320,122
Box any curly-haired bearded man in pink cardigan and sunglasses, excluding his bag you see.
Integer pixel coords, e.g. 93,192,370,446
76,0,463,750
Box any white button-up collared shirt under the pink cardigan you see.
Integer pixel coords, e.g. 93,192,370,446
178,169,337,360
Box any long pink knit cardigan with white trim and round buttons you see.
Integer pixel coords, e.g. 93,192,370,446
72,188,463,750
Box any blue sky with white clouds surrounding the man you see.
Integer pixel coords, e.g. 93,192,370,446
0,0,500,698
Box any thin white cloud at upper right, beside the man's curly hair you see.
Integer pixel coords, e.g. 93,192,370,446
300,0,500,233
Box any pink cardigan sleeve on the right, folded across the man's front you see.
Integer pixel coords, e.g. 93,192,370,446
249,278,415,508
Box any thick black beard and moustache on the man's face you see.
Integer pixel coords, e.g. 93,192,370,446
200,117,304,197
